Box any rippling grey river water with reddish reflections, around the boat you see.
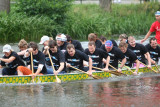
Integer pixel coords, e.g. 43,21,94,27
0,35,160,107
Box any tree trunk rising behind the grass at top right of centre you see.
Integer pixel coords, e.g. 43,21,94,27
99,0,112,12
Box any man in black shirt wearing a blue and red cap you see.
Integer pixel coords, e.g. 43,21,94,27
105,40,126,72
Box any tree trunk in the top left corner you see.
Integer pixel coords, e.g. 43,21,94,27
0,0,10,13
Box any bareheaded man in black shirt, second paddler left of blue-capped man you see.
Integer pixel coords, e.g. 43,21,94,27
65,44,92,75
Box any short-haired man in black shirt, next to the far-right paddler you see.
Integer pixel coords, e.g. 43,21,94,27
128,36,151,68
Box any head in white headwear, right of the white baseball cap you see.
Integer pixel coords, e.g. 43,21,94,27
56,33,67,46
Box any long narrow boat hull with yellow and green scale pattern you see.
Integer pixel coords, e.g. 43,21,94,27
0,66,157,84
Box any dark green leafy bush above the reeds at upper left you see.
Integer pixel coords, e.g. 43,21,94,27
16,0,73,24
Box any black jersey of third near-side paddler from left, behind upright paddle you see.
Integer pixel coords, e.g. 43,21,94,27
45,49,65,70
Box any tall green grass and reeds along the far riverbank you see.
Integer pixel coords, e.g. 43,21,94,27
0,3,160,43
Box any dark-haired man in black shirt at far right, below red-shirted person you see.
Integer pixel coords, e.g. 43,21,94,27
145,37,160,64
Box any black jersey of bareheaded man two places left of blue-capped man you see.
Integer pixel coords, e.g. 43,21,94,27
65,50,89,70
